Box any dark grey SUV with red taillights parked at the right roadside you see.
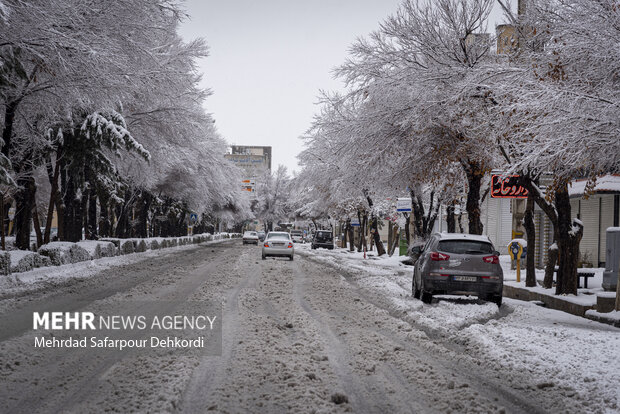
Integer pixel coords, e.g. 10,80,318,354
411,233,504,306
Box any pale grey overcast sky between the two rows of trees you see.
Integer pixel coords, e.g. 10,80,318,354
181,0,508,175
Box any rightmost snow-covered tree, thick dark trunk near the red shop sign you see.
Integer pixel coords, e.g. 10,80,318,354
488,0,620,294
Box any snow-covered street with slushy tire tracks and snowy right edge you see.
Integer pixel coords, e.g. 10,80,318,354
0,240,620,413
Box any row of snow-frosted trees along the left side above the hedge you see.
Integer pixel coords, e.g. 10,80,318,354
0,0,250,249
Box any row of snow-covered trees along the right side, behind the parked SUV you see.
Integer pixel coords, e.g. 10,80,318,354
298,0,620,293
